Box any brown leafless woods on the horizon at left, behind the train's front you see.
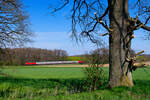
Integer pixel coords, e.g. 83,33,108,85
0,48,68,65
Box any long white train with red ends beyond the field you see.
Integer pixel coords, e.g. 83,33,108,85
25,61,84,65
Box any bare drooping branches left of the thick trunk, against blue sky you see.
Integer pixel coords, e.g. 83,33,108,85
51,0,111,42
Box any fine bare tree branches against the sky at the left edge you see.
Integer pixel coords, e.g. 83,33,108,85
0,0,31,48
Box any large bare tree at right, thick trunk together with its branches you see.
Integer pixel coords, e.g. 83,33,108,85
50,0,150,87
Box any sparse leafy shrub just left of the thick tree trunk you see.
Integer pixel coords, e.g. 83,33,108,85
84,49,104,91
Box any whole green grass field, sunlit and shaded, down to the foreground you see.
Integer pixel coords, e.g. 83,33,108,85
0,66,150,100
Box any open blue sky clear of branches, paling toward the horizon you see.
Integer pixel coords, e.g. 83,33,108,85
23,0,150,55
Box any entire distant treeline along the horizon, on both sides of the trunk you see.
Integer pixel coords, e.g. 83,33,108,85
0,48,150,65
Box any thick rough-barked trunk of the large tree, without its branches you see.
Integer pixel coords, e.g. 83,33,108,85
108,0,133,87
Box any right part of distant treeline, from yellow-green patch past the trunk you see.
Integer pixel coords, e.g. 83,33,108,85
68,48,150,64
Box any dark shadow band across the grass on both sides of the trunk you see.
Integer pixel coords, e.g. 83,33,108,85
0,77,150,92
